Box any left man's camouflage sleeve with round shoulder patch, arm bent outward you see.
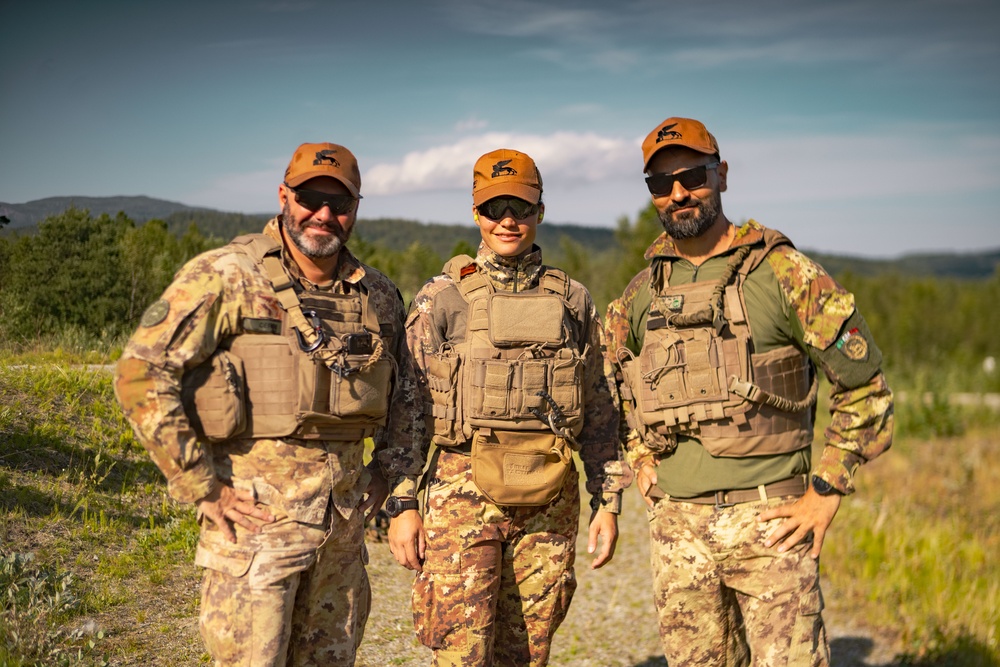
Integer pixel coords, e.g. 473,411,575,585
115,249,280,502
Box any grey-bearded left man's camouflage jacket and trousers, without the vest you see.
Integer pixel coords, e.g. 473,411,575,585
115,218,419,665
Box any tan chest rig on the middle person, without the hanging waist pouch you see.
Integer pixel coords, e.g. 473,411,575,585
426,255,583,446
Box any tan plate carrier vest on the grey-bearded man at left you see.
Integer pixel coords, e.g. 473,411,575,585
182,234,396,442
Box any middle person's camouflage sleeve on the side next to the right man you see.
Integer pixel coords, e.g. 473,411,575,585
572,281,632,514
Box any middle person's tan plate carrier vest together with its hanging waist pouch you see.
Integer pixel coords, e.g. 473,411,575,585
425,255,583,505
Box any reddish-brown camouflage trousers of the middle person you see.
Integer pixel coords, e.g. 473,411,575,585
413,451,580,667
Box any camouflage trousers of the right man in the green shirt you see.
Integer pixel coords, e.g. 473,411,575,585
648,498,830,667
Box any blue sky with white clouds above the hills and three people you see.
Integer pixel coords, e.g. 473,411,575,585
0,0,1000,257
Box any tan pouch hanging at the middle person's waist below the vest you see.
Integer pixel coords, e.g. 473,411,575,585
472,429,573,507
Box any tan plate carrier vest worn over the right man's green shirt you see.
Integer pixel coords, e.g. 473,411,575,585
617,230,818,457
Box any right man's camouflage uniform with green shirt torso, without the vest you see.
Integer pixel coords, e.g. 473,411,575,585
606,220,892,665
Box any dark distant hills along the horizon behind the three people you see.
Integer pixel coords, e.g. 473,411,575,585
0,197,1000,279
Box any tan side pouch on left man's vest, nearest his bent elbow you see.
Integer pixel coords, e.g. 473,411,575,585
181,350,246,442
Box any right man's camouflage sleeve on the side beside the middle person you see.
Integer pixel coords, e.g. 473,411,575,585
604,267,672,470
